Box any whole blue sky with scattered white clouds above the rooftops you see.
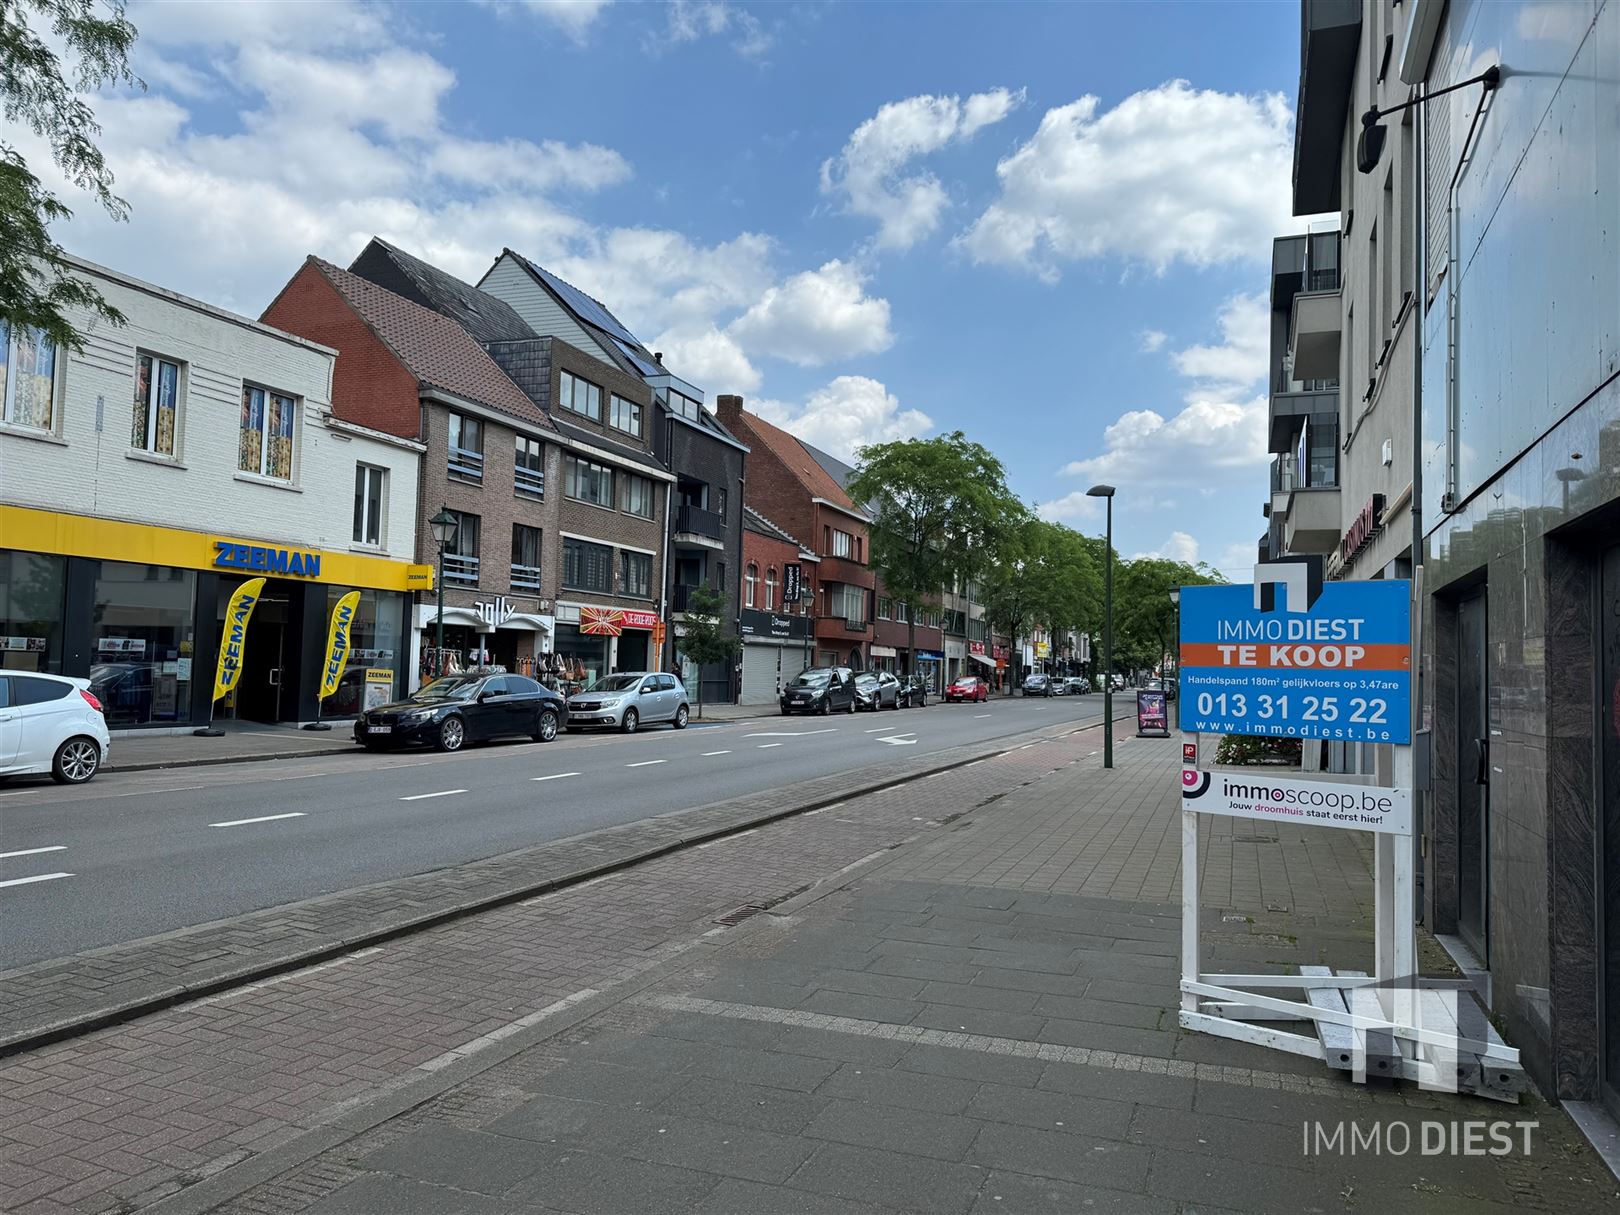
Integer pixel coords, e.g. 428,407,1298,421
44,0,1299,578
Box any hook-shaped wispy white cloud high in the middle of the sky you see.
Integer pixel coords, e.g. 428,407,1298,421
821,89,1024,249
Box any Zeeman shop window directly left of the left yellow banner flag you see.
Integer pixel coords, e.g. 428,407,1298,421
89,561,196,727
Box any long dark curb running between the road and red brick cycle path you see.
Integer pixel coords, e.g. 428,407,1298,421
0,716,1123,1058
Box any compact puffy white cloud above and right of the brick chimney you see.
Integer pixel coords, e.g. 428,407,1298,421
731,259,894,366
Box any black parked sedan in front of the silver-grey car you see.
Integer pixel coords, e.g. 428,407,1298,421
355,674,569,752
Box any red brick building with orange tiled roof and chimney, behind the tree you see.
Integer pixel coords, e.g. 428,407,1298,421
714,397,876,669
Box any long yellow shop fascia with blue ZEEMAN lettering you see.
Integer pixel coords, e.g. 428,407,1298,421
0,505,433,591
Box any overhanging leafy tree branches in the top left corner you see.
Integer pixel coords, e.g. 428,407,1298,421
0,0,141,350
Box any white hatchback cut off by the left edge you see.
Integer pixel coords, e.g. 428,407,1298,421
0,671,112,784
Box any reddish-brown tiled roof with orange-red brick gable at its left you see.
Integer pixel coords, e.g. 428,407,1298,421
308,256,551,429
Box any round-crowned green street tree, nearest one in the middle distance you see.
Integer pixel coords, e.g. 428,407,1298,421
844,431,1024,677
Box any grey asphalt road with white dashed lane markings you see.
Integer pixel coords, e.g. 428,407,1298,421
0,695,1119,969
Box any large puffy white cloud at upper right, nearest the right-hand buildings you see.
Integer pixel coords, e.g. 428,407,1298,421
959,81,1301,277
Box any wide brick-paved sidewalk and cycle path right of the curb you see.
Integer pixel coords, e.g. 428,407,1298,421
0,732,1617,1215
